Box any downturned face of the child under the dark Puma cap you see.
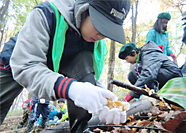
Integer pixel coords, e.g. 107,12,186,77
80,16,105,42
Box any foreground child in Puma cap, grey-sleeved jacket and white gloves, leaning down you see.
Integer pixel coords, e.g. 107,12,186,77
0,0,131,132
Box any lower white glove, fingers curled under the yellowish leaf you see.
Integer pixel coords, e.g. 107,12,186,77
99,102,130,124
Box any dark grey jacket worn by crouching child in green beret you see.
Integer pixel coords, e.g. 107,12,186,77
132,41,182,87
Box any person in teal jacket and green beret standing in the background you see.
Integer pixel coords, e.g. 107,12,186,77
145,12,176,63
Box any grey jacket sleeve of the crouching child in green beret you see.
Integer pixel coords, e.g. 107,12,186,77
135,52,162,88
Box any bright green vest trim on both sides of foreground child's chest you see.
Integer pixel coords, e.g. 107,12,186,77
49,1,107,80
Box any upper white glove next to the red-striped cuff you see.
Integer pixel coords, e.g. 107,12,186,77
69,82,117,113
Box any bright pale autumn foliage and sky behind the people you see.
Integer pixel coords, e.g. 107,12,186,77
0,0,186,99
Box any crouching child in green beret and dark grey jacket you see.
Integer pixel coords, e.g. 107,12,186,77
118,41,182,101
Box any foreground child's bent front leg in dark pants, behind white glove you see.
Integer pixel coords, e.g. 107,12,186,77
62,51,96,133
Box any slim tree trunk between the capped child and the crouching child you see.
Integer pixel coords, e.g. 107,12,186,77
107,40,115,91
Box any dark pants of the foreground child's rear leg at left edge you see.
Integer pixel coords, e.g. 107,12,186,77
0,72,23,125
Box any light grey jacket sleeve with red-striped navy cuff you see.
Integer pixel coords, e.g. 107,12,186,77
10,8,75,100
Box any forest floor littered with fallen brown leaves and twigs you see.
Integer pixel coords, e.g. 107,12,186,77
0,99,186,133
